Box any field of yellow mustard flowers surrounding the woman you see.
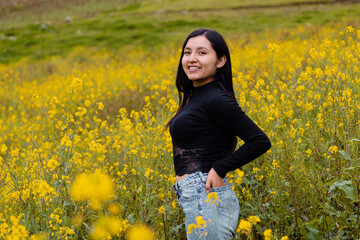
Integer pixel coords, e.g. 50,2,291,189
0,19,360,240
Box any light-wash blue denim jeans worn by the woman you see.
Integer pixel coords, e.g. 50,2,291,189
173,172,240,240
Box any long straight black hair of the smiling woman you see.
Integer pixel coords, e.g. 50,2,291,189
165,29,236,151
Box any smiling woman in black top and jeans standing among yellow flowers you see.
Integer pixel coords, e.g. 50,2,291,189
167,29,271,240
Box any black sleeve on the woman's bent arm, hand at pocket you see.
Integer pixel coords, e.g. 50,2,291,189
206,93,271,178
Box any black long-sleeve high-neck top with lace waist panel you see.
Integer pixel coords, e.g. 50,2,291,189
170,81,271,178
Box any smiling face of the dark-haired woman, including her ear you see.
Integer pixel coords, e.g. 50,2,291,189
181,35,226,87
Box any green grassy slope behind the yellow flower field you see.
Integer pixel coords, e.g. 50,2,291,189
0,0,360,64
